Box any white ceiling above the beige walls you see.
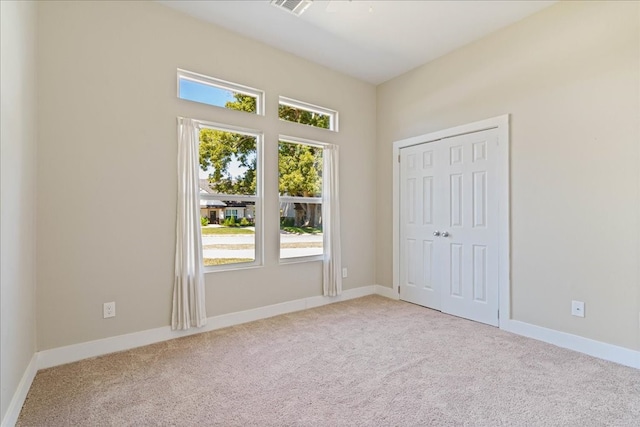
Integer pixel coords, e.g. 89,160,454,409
160,0,555,84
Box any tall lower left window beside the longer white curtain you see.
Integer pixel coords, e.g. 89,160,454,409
200,125,262,266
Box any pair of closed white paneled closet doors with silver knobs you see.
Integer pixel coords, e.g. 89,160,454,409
400,129,499,326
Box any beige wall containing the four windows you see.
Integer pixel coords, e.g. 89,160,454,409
38,2,376,350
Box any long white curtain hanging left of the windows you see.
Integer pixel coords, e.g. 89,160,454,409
171,118,207,330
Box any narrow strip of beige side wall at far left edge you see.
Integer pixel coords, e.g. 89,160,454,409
0,1,37,420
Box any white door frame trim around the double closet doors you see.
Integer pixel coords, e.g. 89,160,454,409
392,114,511,329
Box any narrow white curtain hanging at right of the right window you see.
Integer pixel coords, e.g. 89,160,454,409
322,145,342,297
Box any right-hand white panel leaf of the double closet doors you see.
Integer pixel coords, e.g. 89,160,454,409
438,129,499,326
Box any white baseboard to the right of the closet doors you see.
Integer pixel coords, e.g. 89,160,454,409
501,320,640,369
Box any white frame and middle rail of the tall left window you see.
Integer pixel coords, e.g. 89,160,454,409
194,119,264,273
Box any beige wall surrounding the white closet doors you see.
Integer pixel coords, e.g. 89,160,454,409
376,2,640,350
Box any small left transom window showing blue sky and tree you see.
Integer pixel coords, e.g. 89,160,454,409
178,69,264,115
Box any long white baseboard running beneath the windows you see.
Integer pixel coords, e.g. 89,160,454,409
38,285,376,369
